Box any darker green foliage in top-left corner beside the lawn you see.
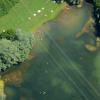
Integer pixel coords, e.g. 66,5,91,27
0,0,19,16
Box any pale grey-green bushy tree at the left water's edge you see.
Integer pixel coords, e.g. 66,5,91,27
0,31,33,71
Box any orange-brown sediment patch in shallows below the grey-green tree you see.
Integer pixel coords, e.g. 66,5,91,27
2,57,34,86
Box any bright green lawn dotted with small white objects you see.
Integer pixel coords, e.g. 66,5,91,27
0,0,64,32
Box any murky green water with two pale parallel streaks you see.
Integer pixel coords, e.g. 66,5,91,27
6,4,100,100
